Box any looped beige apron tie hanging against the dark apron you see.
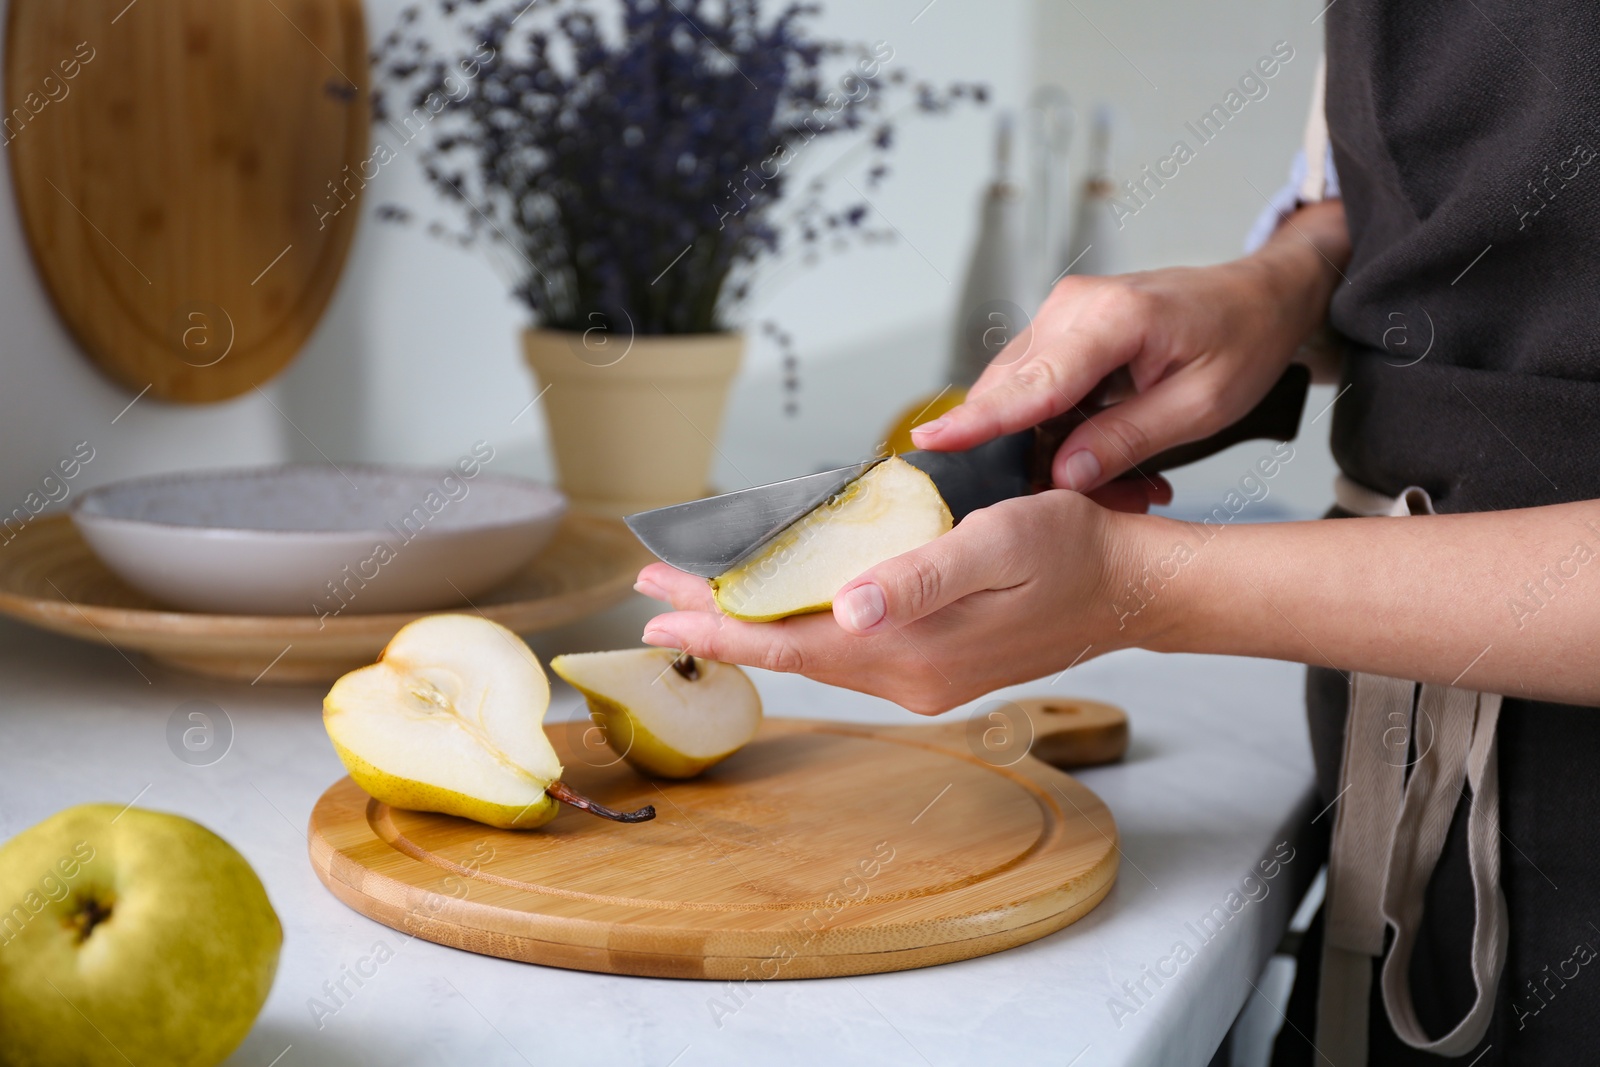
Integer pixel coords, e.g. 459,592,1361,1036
1382,686,1509,1056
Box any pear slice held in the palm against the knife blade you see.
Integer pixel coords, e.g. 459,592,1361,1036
710,456,954,622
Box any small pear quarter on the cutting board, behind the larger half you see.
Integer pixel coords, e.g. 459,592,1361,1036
550,648,762,777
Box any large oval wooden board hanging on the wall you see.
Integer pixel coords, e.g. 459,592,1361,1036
0,0,374,403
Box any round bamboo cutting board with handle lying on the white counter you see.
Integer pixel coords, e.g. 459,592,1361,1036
309,699,1128,981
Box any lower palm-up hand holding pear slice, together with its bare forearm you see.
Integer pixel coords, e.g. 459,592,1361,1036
637,490,1600,713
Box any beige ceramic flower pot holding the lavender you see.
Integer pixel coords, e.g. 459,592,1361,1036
523,330,744,515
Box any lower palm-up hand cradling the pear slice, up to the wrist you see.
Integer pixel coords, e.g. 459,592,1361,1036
637,490,1138,715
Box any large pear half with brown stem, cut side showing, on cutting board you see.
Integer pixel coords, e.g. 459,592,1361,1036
322,614,656,830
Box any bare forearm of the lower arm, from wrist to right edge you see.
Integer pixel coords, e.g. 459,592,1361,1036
1112,501,1600,704
